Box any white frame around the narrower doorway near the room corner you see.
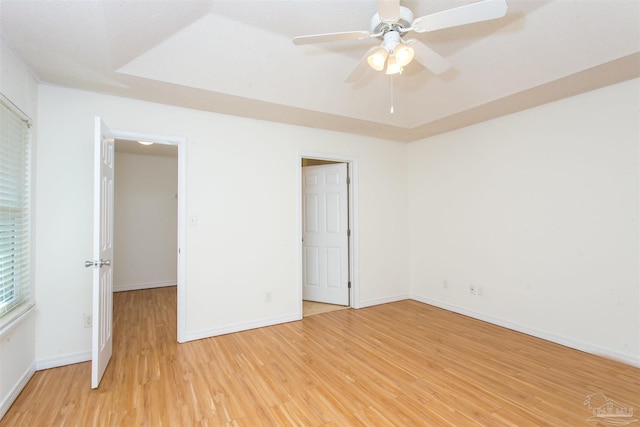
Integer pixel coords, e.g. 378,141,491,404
295,151,360,319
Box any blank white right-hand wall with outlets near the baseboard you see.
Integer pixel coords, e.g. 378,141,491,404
409,80,640,365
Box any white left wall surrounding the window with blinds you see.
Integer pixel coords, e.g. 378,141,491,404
0,39,37,418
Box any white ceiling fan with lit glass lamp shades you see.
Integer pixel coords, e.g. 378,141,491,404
293,0,507,83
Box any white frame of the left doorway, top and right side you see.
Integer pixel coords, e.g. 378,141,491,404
111,129,187,343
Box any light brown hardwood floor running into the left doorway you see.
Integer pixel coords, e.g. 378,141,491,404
0,288,640,427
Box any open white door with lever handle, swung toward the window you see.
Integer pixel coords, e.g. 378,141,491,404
87,117,115,388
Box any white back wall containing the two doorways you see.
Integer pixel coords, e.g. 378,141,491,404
36,86,409,366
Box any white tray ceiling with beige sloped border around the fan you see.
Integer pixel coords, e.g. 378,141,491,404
0,0,640,141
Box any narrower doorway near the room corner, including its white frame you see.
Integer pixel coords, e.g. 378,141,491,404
299,155,357,317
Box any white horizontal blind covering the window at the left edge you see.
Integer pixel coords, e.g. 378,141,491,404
0,96,30,317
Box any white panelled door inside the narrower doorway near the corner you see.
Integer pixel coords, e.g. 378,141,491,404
302,163,349,305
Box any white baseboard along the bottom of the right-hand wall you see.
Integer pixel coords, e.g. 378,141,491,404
411,295,640,368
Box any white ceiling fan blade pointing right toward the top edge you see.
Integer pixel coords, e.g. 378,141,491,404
411,0,507,33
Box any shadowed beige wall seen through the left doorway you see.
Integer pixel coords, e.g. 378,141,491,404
113,151,178,291
